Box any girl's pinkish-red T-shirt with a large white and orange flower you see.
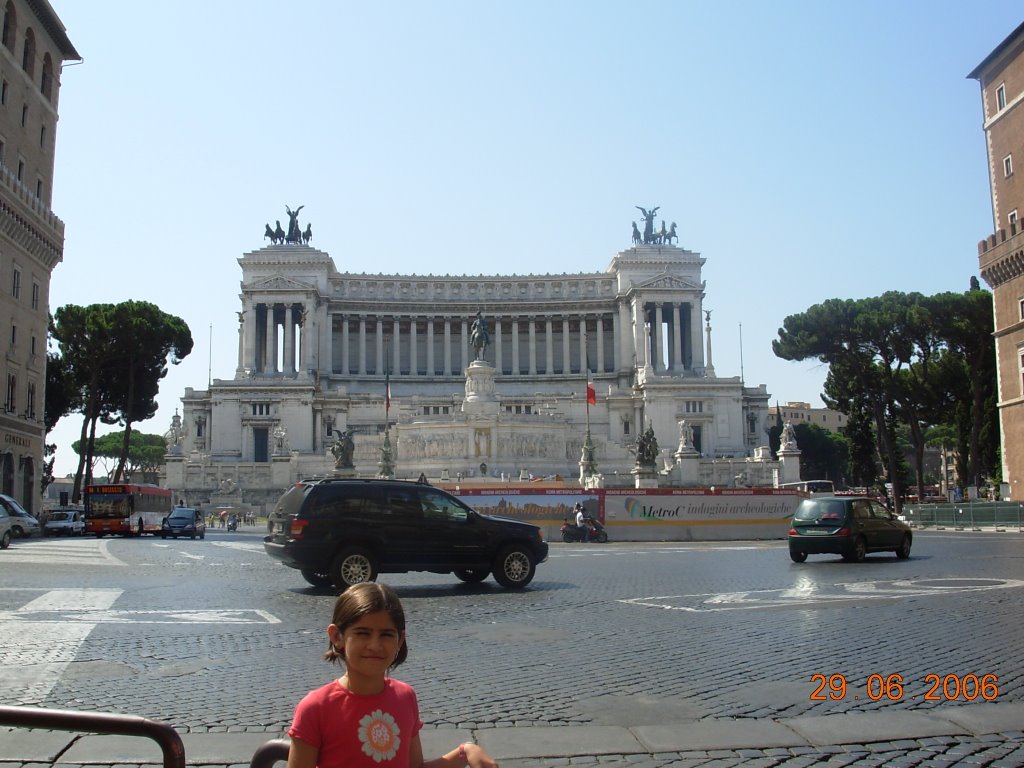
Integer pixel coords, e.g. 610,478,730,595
288,678,423,768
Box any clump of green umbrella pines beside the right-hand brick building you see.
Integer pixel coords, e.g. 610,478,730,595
772,290,998,504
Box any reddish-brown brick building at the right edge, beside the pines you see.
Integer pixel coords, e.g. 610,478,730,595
968,24,1024,500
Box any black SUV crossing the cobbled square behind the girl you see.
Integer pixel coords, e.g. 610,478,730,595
263,479,548,589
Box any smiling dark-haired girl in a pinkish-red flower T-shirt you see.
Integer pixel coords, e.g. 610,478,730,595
288,582,498,768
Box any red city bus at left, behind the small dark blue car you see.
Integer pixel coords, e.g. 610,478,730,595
84,483,173,537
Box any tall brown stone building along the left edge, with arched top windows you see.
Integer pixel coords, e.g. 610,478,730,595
0,0,81,513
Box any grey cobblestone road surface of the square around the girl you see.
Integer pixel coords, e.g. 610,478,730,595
0,531,1024,768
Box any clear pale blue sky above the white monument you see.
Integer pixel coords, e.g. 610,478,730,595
50,0,1022,476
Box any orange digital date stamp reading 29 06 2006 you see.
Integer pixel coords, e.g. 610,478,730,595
810,673,999,701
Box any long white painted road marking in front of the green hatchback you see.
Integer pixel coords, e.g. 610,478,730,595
618,579,1024,613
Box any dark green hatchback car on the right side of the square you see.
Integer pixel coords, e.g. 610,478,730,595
790,496,913,562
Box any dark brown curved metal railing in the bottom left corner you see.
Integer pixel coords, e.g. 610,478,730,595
0,707,185,768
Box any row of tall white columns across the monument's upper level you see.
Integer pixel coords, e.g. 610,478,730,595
238,293,703,376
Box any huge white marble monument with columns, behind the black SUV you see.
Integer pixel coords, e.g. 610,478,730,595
166,222,774,512
